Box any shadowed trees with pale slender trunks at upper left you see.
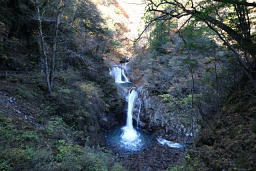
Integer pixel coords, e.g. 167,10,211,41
0,0,114,92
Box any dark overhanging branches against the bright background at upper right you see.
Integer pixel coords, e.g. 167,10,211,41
146,0,256,86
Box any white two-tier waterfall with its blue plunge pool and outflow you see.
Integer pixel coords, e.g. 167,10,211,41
106,63,180,151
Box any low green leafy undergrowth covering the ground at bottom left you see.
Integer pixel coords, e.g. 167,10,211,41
0,111,122,171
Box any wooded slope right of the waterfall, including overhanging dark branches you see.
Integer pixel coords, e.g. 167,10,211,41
133,0,256,170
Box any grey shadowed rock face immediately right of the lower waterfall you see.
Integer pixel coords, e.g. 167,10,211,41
134,87,196,143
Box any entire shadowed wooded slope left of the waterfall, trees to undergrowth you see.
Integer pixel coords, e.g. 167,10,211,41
0,0,122,170
